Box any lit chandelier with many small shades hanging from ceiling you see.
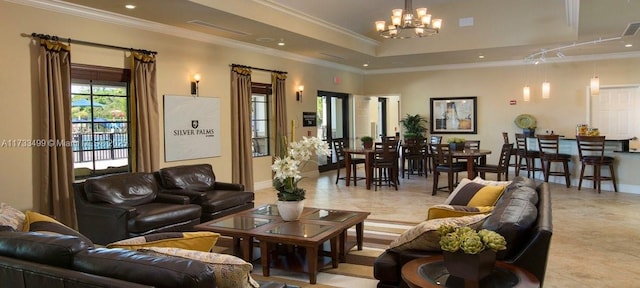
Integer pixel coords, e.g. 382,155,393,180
376,0,442,39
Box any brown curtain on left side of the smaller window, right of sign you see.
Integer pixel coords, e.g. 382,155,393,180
231,66,253,191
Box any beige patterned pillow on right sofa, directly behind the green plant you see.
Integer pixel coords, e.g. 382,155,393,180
389,214,488,251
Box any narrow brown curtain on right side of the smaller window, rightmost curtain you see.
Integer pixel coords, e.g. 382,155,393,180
271,72,288,157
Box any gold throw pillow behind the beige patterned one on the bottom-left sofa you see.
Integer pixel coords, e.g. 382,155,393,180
107,232,220,252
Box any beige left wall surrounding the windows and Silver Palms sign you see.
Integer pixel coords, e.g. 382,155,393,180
0,1,363,210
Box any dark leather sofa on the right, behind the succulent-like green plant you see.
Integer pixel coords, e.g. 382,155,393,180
373,176,553,288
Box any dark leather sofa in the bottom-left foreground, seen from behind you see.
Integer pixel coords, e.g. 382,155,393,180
0,231,216,288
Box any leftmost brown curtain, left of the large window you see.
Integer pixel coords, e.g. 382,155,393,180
34,39,77,227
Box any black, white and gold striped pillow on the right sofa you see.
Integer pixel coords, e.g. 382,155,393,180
444,179,506,207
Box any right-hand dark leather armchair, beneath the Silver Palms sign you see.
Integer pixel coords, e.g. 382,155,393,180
156,164,255,222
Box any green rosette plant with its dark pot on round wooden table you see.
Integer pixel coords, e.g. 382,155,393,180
438,225,507,282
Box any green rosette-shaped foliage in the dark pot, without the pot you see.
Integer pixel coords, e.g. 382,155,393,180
438,225,507,254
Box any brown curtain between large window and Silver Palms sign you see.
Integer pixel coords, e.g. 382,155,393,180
131,51,160,172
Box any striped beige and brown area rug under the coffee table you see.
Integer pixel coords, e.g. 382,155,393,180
216,220,416,288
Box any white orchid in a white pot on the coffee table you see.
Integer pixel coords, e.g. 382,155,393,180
271,137,331,221
